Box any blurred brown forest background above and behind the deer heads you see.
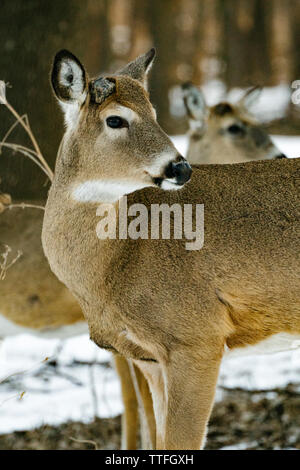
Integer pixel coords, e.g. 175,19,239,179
0,0,300,197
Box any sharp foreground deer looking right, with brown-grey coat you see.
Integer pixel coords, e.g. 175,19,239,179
42,51,300,449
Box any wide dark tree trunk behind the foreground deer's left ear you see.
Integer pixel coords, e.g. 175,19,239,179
0,0,108,198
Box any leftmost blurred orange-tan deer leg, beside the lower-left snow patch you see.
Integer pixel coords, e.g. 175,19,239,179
114,355,138,450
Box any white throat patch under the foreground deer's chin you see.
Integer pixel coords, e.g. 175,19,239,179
72,180,149,203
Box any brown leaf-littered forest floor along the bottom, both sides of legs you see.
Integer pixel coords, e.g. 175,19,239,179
0,384,300,450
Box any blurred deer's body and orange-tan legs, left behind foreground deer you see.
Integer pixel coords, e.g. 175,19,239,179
0,198,150,449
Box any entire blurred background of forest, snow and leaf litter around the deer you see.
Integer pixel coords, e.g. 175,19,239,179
0,0,300,449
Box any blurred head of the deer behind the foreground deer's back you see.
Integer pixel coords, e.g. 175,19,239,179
182,83,285,165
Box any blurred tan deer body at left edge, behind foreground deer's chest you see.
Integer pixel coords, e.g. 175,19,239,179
0,202,87,338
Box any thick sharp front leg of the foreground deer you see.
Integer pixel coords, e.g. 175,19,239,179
149,346,222,450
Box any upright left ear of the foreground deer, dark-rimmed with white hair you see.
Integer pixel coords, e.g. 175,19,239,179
51,49,87,104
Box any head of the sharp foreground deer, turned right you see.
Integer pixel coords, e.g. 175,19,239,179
51,49,191,202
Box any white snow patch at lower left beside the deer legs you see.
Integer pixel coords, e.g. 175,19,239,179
0,335,122,434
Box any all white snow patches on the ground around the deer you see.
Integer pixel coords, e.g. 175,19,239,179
0,136,300,434
